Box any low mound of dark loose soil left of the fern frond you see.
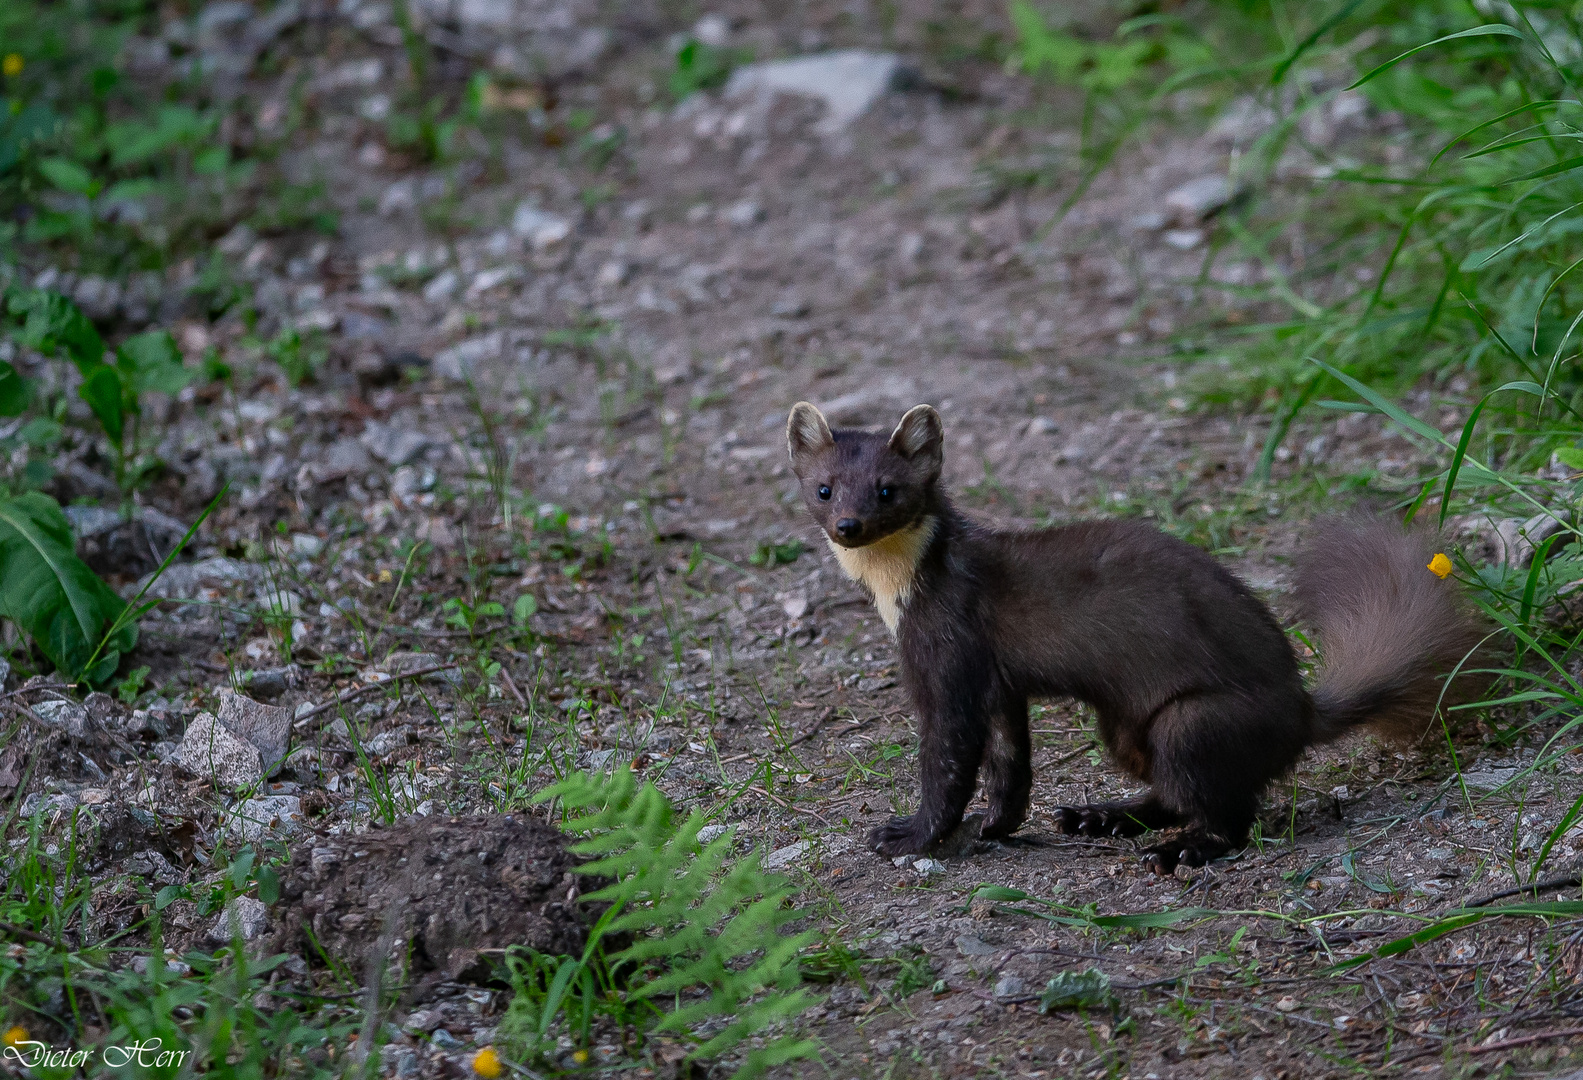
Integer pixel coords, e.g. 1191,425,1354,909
272,816,602,985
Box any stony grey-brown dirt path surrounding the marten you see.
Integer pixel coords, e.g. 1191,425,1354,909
12,0,1583,1080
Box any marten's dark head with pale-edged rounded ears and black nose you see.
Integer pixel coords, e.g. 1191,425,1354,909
787,401,945,548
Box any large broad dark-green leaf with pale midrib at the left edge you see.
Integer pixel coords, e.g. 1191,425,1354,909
0,491,138,679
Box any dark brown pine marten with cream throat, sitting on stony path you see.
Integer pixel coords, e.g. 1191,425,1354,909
787,402,1480,874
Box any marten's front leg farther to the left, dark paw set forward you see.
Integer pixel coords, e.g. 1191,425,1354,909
869,665,989,857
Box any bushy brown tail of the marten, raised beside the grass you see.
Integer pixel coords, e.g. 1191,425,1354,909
1296,519,1490,741
